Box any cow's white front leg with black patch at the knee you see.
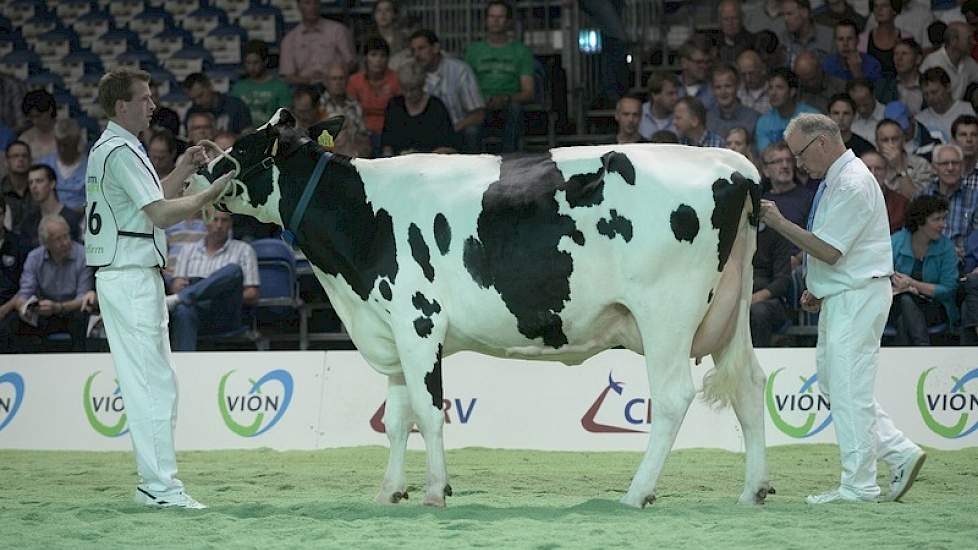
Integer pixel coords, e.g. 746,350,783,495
395,313,452,506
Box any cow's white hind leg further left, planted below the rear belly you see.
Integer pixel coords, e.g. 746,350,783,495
621,322,696,508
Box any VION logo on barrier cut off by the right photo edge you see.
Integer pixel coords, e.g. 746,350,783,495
917,367,978,439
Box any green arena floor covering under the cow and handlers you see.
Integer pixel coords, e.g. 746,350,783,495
0,445,978,550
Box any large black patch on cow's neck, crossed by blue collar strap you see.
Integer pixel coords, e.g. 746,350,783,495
270,144,398,301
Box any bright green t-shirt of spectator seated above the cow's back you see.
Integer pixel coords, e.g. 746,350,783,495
465,41,533,99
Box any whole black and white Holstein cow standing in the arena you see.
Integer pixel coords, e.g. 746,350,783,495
194,109,773,507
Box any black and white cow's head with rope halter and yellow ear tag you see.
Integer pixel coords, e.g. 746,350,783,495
185,109,342,225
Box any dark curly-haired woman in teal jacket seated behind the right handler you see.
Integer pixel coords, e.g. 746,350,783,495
888,195,958,346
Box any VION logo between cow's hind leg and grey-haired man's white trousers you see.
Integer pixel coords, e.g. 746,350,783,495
764,369,832,439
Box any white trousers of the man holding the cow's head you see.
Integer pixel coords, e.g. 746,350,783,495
95,269,183,496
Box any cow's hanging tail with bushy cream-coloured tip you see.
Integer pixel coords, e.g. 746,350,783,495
703,174,764,407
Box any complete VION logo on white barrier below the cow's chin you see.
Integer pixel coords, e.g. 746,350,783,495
217,369,292,437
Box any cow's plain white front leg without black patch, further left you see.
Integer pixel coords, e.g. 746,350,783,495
377,374,414,504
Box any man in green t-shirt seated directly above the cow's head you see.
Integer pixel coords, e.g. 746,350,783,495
231,40,292,127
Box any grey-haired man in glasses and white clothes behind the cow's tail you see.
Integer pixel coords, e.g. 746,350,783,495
761,114,926,504
